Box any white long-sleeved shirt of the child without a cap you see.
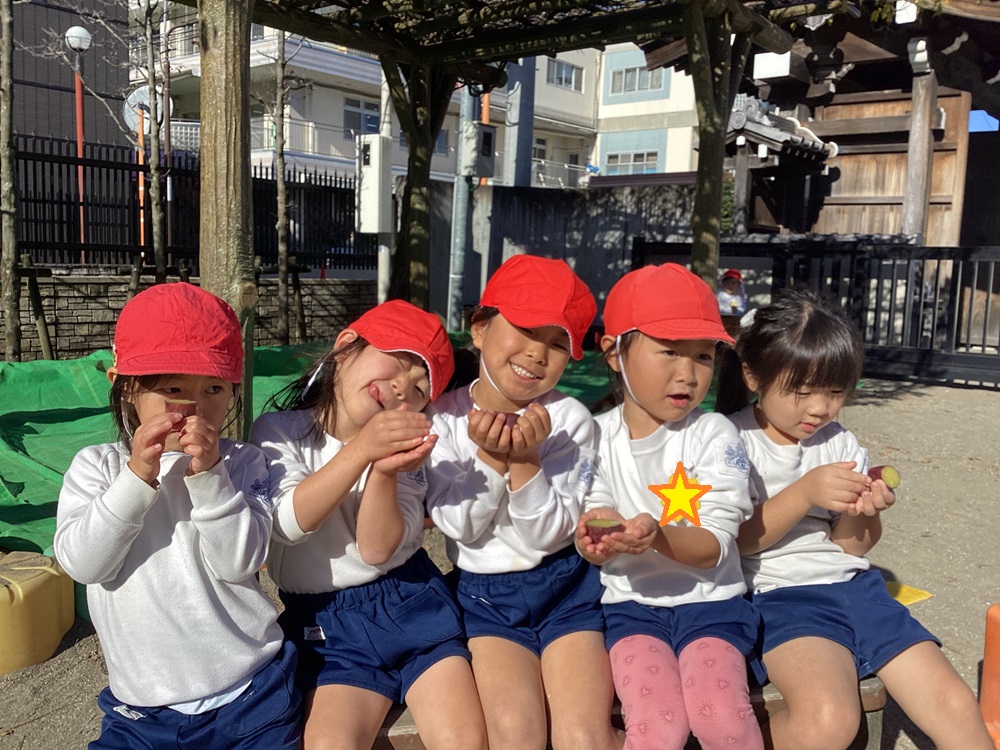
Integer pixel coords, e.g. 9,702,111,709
730,406,870,594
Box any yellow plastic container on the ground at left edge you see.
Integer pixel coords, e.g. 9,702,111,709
0,552,75,674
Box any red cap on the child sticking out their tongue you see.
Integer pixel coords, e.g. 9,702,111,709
348,299,455,401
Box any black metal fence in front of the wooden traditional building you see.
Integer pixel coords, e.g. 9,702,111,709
633,237,1000,387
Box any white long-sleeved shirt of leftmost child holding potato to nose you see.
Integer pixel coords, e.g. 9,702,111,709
55,440,282,706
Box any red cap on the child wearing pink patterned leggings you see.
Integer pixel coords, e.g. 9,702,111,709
604,263,734,344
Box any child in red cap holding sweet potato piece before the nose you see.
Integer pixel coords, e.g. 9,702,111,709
55,283,301,750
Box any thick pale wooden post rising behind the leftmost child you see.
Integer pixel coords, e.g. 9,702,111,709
199,0,257,438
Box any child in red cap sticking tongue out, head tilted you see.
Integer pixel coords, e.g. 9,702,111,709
251,300,486,750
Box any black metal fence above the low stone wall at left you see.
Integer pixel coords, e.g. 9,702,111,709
15,135,377,273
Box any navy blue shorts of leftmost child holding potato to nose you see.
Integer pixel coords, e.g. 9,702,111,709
88,642,302,750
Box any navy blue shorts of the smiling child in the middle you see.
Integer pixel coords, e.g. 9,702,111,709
457,544,604,656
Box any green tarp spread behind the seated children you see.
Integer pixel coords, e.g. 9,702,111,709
0,344,608,552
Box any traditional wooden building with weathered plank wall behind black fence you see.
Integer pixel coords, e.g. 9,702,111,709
646,0,1000,246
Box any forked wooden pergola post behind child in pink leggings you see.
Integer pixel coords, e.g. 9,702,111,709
685,0,750,289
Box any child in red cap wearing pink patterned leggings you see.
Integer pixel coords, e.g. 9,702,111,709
576,263,763,750
